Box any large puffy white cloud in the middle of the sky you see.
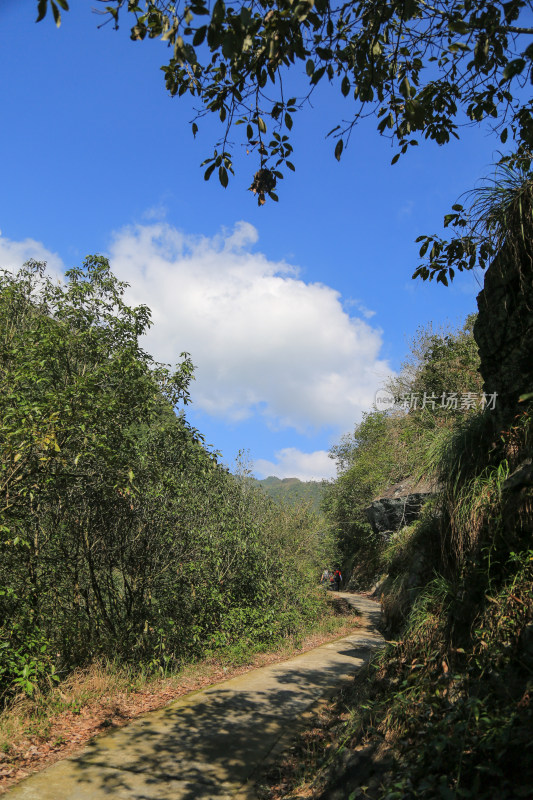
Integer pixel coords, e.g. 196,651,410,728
110,222,391,432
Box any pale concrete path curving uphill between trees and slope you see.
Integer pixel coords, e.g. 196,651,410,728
6,592,383,800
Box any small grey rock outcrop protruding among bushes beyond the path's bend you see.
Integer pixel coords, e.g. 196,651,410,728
365,479,436,539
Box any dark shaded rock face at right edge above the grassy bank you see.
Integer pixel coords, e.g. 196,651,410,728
474,248,533,415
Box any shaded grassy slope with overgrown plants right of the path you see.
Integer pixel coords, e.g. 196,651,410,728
262,340,533,800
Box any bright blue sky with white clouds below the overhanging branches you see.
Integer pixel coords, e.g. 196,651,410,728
0,0,499,479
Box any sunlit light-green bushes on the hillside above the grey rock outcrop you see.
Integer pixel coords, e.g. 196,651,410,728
324,316,482,581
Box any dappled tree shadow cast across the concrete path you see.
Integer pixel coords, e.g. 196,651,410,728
64,639,384,800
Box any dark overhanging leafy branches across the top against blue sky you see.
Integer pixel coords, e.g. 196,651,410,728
37,0,533,283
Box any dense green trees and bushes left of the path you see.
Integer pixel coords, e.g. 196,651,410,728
0,257,323,697
